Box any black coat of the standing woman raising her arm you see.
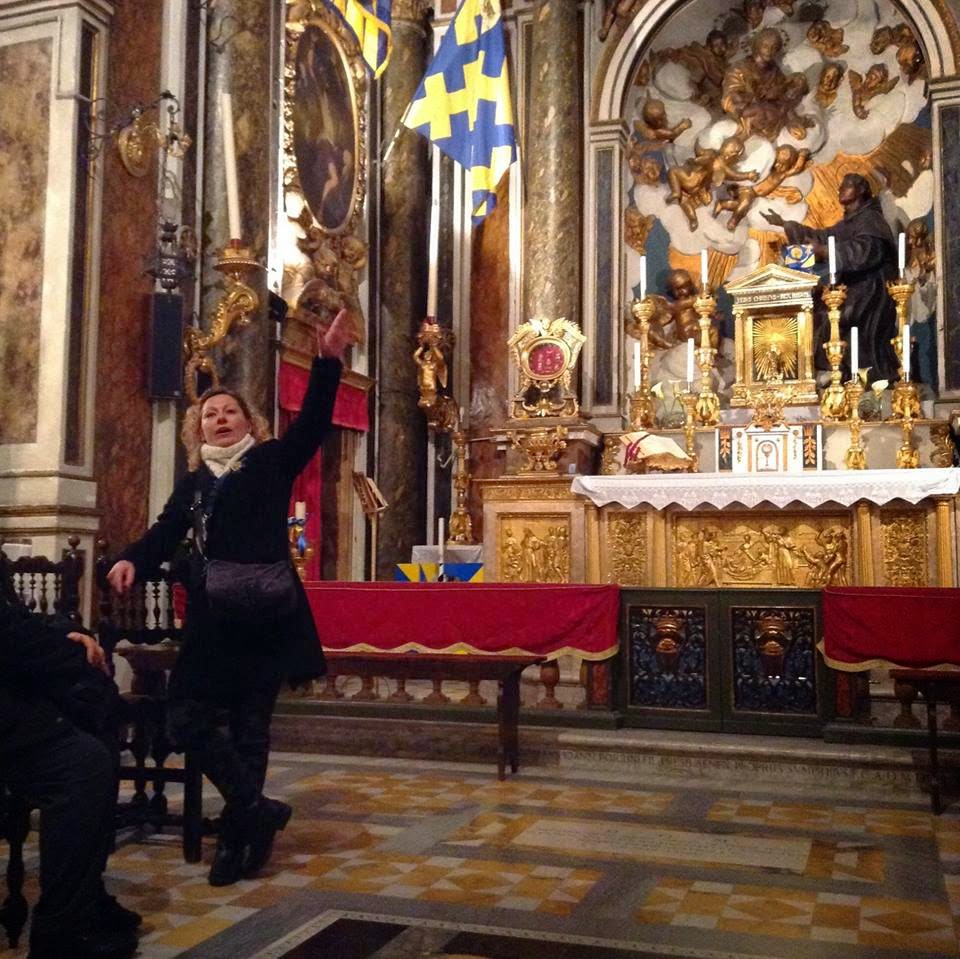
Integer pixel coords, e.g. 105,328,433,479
120,358,342,701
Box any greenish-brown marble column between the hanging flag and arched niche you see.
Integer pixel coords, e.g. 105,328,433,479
521,0,582,323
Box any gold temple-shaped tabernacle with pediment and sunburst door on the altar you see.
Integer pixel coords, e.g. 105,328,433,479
725,263,819,407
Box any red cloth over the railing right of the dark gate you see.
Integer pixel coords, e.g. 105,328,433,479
820,586,960,672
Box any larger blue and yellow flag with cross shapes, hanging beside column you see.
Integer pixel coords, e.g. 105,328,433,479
403,0,517,223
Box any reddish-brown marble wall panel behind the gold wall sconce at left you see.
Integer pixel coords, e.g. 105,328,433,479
94,3,163,548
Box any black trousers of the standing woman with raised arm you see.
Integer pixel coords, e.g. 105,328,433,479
167,676,280,827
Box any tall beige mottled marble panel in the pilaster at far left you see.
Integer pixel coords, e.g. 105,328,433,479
0,39,52,443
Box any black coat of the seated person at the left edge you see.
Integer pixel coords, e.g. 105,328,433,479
0,597,92,758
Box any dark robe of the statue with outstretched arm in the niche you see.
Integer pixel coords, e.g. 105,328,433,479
784,197,898,381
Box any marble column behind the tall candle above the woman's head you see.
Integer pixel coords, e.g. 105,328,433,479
201,0,277,419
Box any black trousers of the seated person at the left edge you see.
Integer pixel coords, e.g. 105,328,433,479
0,723,117,938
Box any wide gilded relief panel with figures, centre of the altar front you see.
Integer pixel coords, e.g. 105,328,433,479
670,513,855,589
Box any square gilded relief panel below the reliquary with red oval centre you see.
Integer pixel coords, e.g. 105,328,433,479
497,513,570,583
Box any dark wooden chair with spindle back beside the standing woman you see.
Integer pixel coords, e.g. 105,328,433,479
97,541,209,862
